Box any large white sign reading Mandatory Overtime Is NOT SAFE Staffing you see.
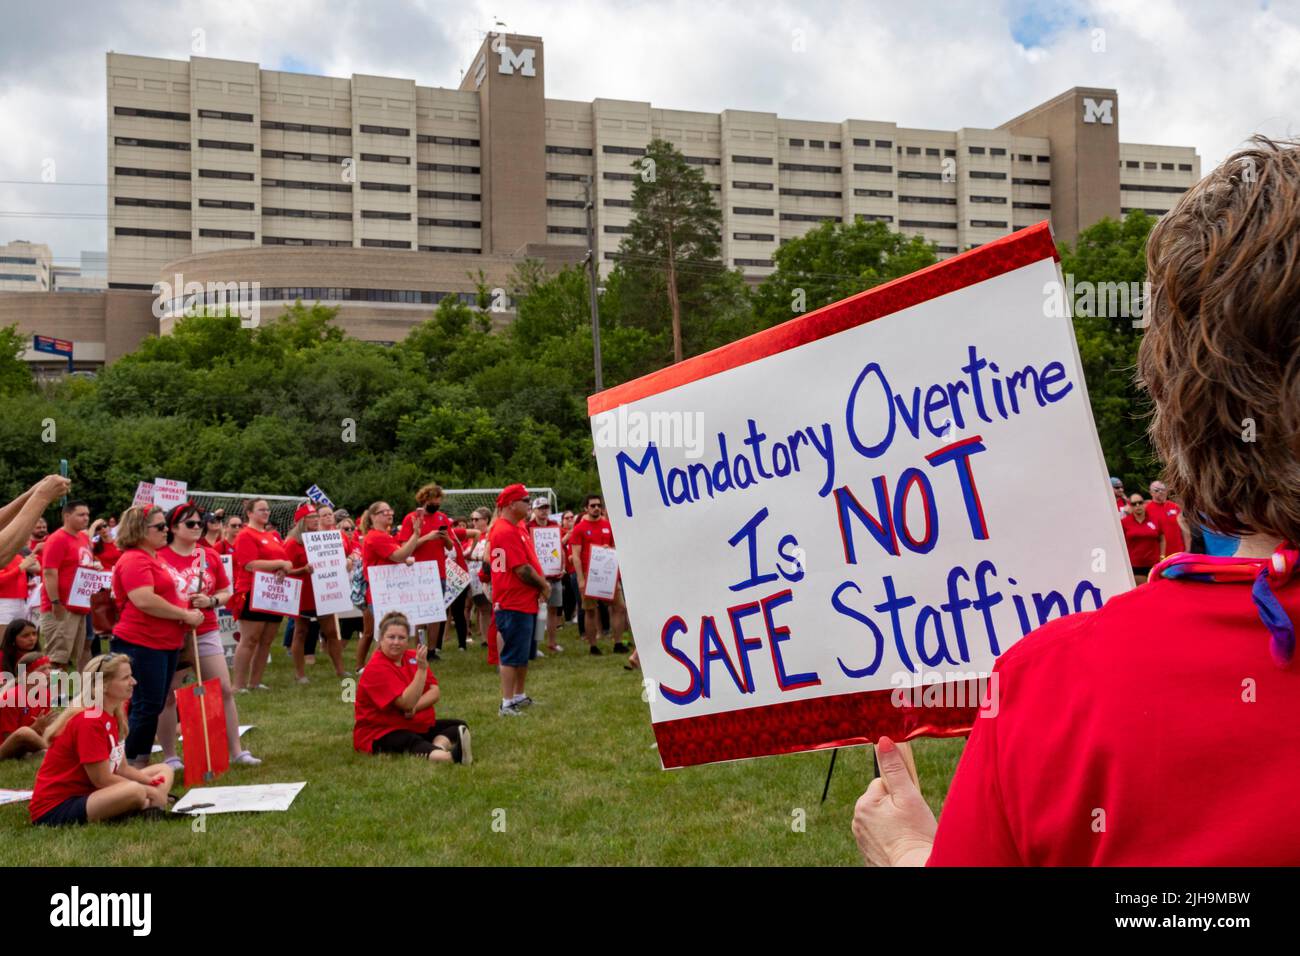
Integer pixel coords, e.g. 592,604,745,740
588,224,1132,767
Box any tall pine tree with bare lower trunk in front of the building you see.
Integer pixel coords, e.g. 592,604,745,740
619,139,727,362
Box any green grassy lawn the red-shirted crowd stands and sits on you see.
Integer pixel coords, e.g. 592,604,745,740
0,627,962,866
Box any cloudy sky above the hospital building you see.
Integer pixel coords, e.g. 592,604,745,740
0,0,1300,264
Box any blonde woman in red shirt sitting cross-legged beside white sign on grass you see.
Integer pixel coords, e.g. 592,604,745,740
29,654,172,826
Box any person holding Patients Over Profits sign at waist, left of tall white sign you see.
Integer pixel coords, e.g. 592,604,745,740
230,498,294,693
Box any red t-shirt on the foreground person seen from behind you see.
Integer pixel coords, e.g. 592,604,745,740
930,579,1300,866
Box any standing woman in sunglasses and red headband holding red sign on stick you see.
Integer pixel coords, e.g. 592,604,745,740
159,505,261,771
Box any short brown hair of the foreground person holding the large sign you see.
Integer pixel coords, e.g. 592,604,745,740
1138,137,1300,544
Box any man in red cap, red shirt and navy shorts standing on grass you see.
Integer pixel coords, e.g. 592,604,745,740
488,484,551,717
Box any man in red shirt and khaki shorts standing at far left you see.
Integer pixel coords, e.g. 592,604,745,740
40,499,95,670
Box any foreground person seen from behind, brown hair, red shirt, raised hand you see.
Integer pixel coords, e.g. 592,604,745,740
853,137,1300,866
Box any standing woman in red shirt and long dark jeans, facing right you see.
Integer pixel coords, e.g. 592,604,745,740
110,505,204,766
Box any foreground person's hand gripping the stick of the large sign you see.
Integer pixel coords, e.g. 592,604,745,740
853,737,939,866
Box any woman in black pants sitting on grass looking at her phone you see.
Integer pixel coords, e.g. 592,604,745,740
352,611,473,763
